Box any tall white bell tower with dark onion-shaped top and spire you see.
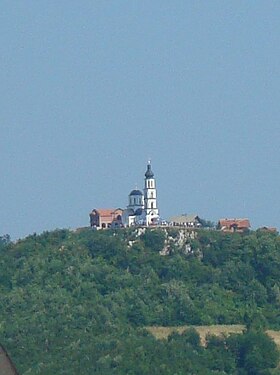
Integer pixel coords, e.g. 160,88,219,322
144,161,159,226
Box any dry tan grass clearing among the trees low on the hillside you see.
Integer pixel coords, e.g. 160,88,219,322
147,324,280,348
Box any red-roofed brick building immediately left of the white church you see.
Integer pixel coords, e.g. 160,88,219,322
89,208,123,229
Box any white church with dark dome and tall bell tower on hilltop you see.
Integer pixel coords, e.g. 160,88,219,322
122,161,159,226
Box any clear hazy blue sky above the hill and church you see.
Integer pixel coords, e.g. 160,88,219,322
0,0,280,239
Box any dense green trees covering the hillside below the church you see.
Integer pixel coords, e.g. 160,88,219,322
0,229,280,375
